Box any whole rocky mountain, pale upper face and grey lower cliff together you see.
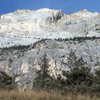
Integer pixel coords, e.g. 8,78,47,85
0,9,100,89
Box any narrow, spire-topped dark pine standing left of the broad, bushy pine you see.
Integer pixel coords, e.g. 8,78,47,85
33,54,53,89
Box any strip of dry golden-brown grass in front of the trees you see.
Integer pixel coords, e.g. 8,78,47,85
0,90,100,100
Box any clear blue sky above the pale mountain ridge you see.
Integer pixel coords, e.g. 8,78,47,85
0,0,100,14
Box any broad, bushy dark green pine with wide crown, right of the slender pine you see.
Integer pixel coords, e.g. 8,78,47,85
64,50,92,90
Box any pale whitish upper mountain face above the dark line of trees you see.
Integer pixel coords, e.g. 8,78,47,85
0,8,100,48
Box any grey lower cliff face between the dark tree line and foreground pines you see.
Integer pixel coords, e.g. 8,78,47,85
0,39,100,89
